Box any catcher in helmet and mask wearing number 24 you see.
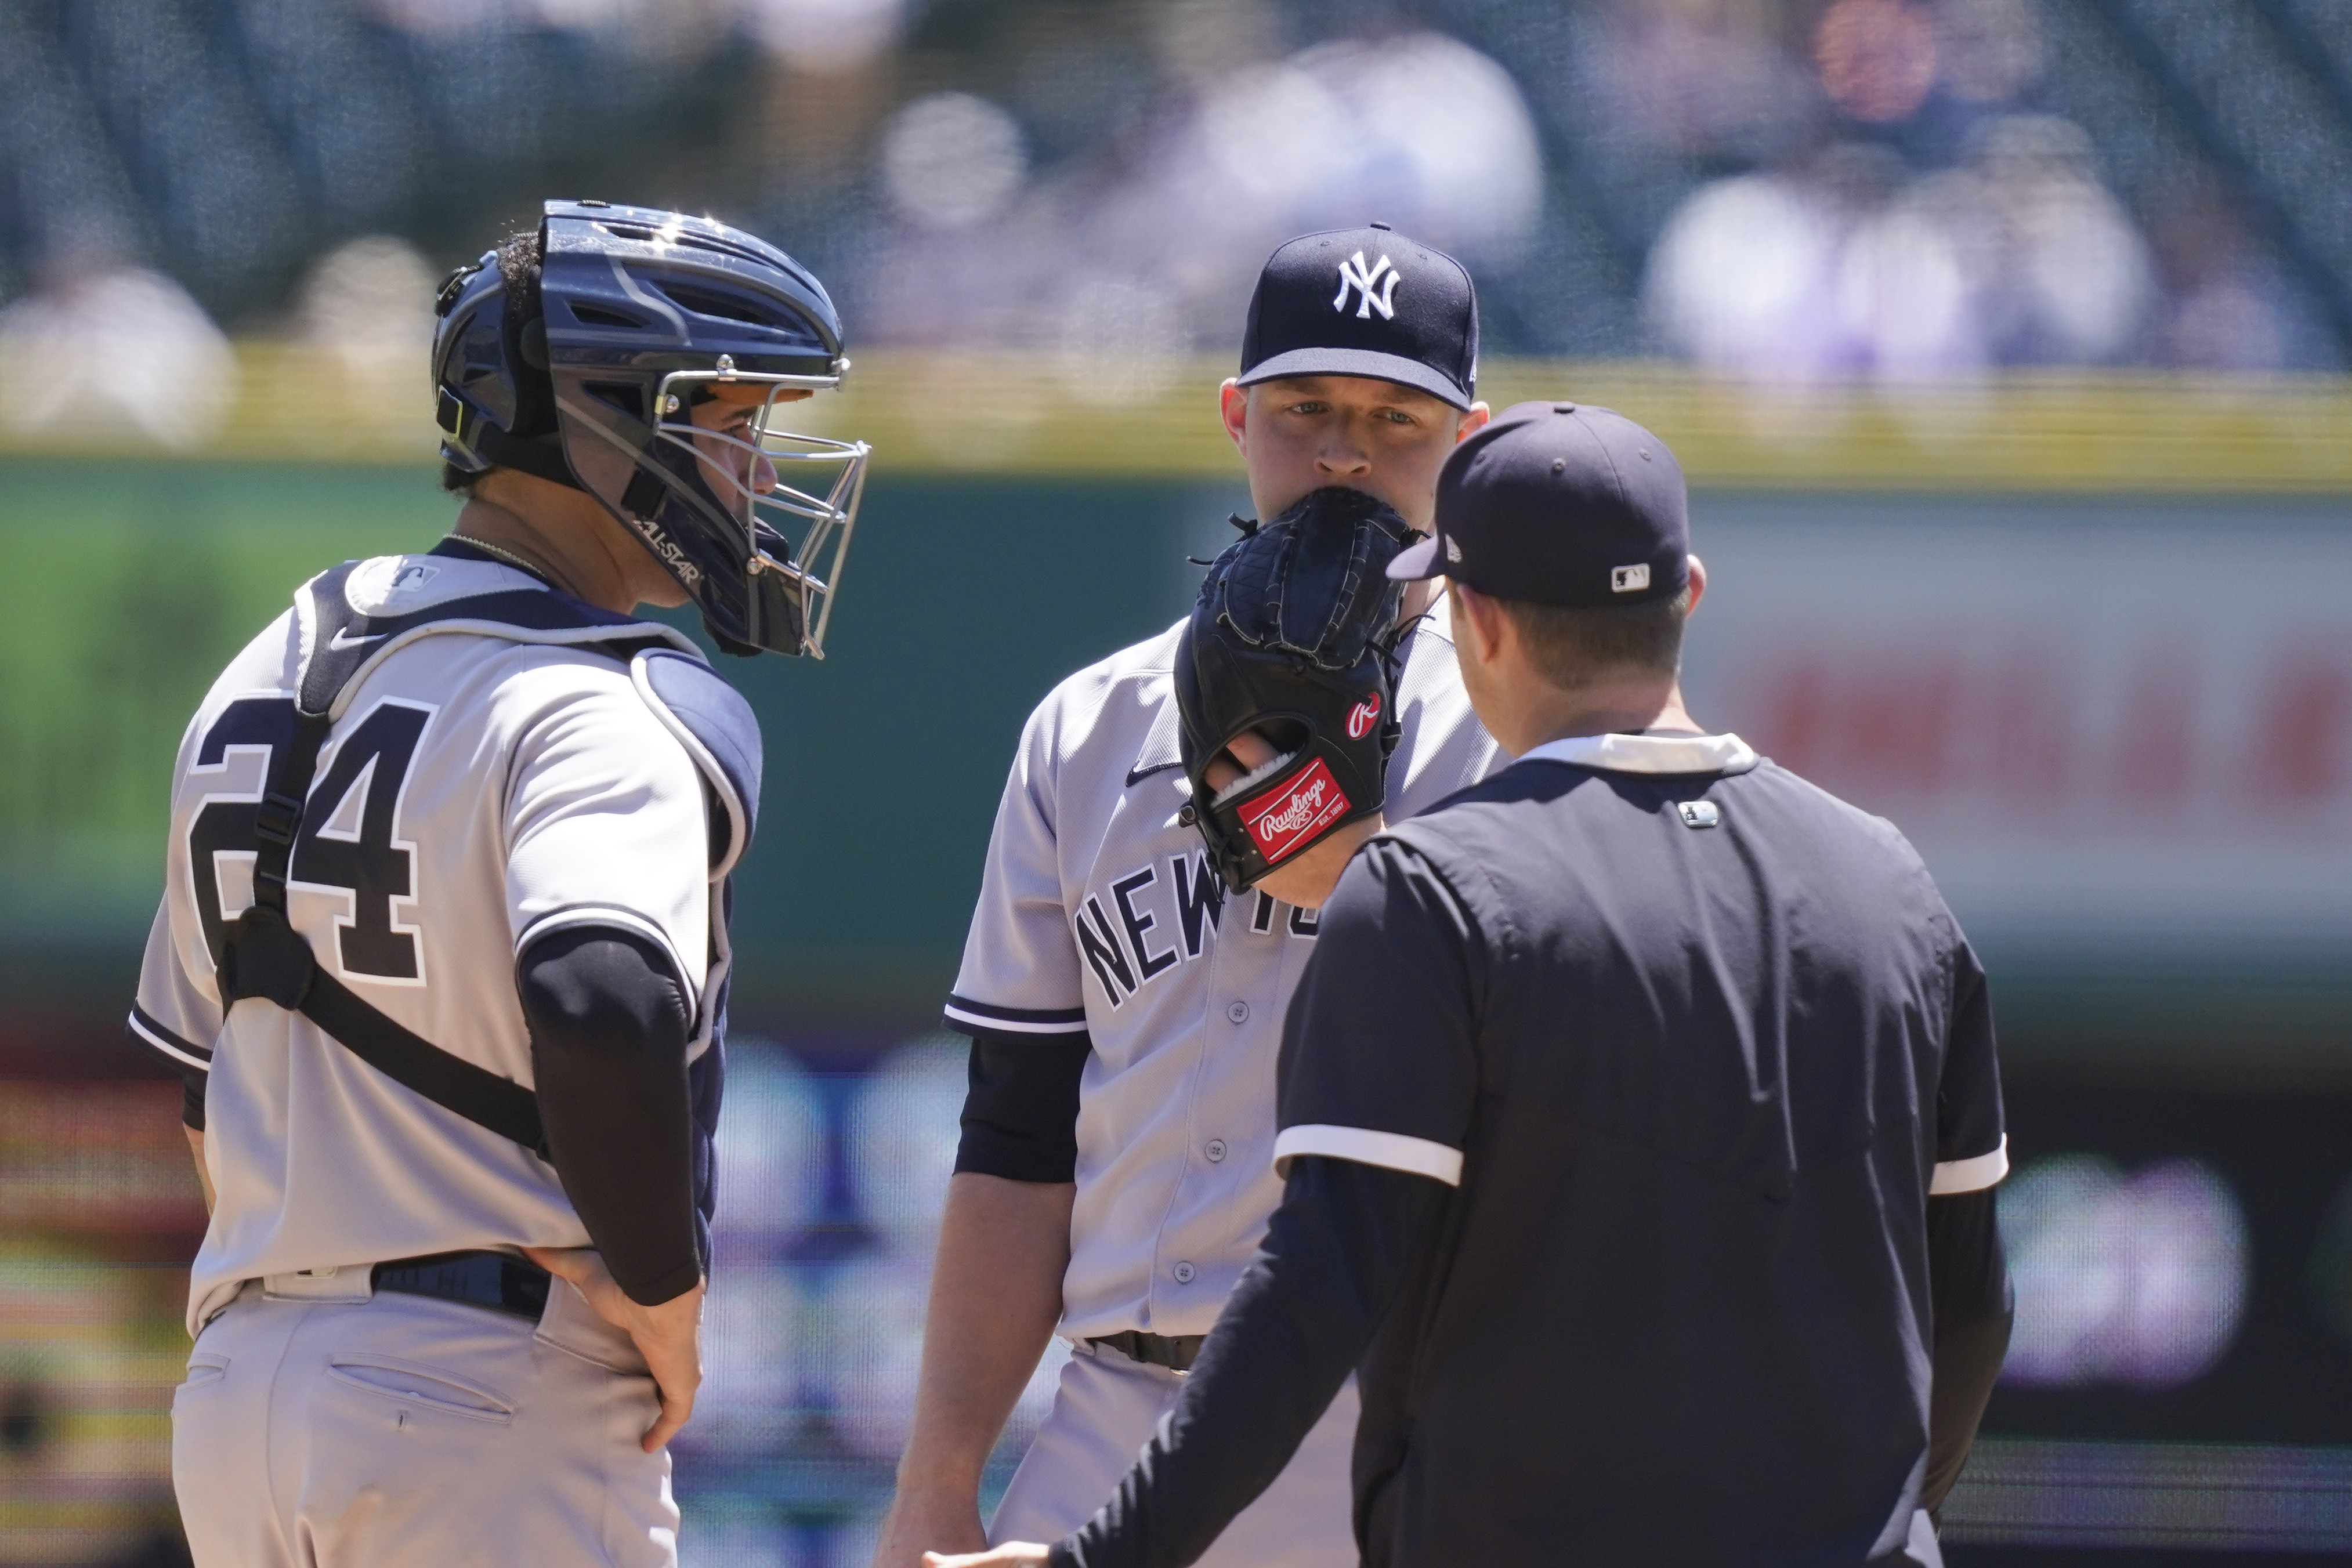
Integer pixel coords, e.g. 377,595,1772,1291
129,202,866,1568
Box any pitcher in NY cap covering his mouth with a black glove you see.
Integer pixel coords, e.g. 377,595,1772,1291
875,226,1496,1568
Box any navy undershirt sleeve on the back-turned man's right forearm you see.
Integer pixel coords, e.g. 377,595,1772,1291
1919,1187,2016,1512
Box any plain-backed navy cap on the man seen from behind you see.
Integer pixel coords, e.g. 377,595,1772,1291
1388,402,1691,607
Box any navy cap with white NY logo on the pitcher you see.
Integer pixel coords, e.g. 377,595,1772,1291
1242,223,1477,409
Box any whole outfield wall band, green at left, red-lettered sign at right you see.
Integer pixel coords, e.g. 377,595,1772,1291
0,454,2352,1081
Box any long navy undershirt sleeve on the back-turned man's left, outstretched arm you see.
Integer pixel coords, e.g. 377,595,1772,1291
1049,1154,1451,1568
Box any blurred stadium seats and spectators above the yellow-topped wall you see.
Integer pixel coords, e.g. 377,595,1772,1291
0,0,2352,447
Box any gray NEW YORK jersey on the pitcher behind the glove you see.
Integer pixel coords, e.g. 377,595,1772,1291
948,599,1496,1340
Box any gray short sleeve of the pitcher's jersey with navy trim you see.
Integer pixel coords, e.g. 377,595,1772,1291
948,693,1086,1034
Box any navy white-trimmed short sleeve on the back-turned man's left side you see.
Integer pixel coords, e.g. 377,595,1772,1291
1275,835,1489,1187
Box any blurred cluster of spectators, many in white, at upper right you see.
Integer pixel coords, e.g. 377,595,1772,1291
1593,0,2310,383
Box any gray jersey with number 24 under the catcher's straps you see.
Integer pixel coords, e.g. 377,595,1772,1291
132,555,727,1333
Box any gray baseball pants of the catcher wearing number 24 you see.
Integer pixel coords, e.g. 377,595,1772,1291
172,1269,678,1568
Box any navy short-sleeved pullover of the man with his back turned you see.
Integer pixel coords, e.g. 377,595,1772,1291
1282,738,2002,1561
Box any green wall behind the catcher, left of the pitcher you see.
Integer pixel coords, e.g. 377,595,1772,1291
0,458,1244,1044
